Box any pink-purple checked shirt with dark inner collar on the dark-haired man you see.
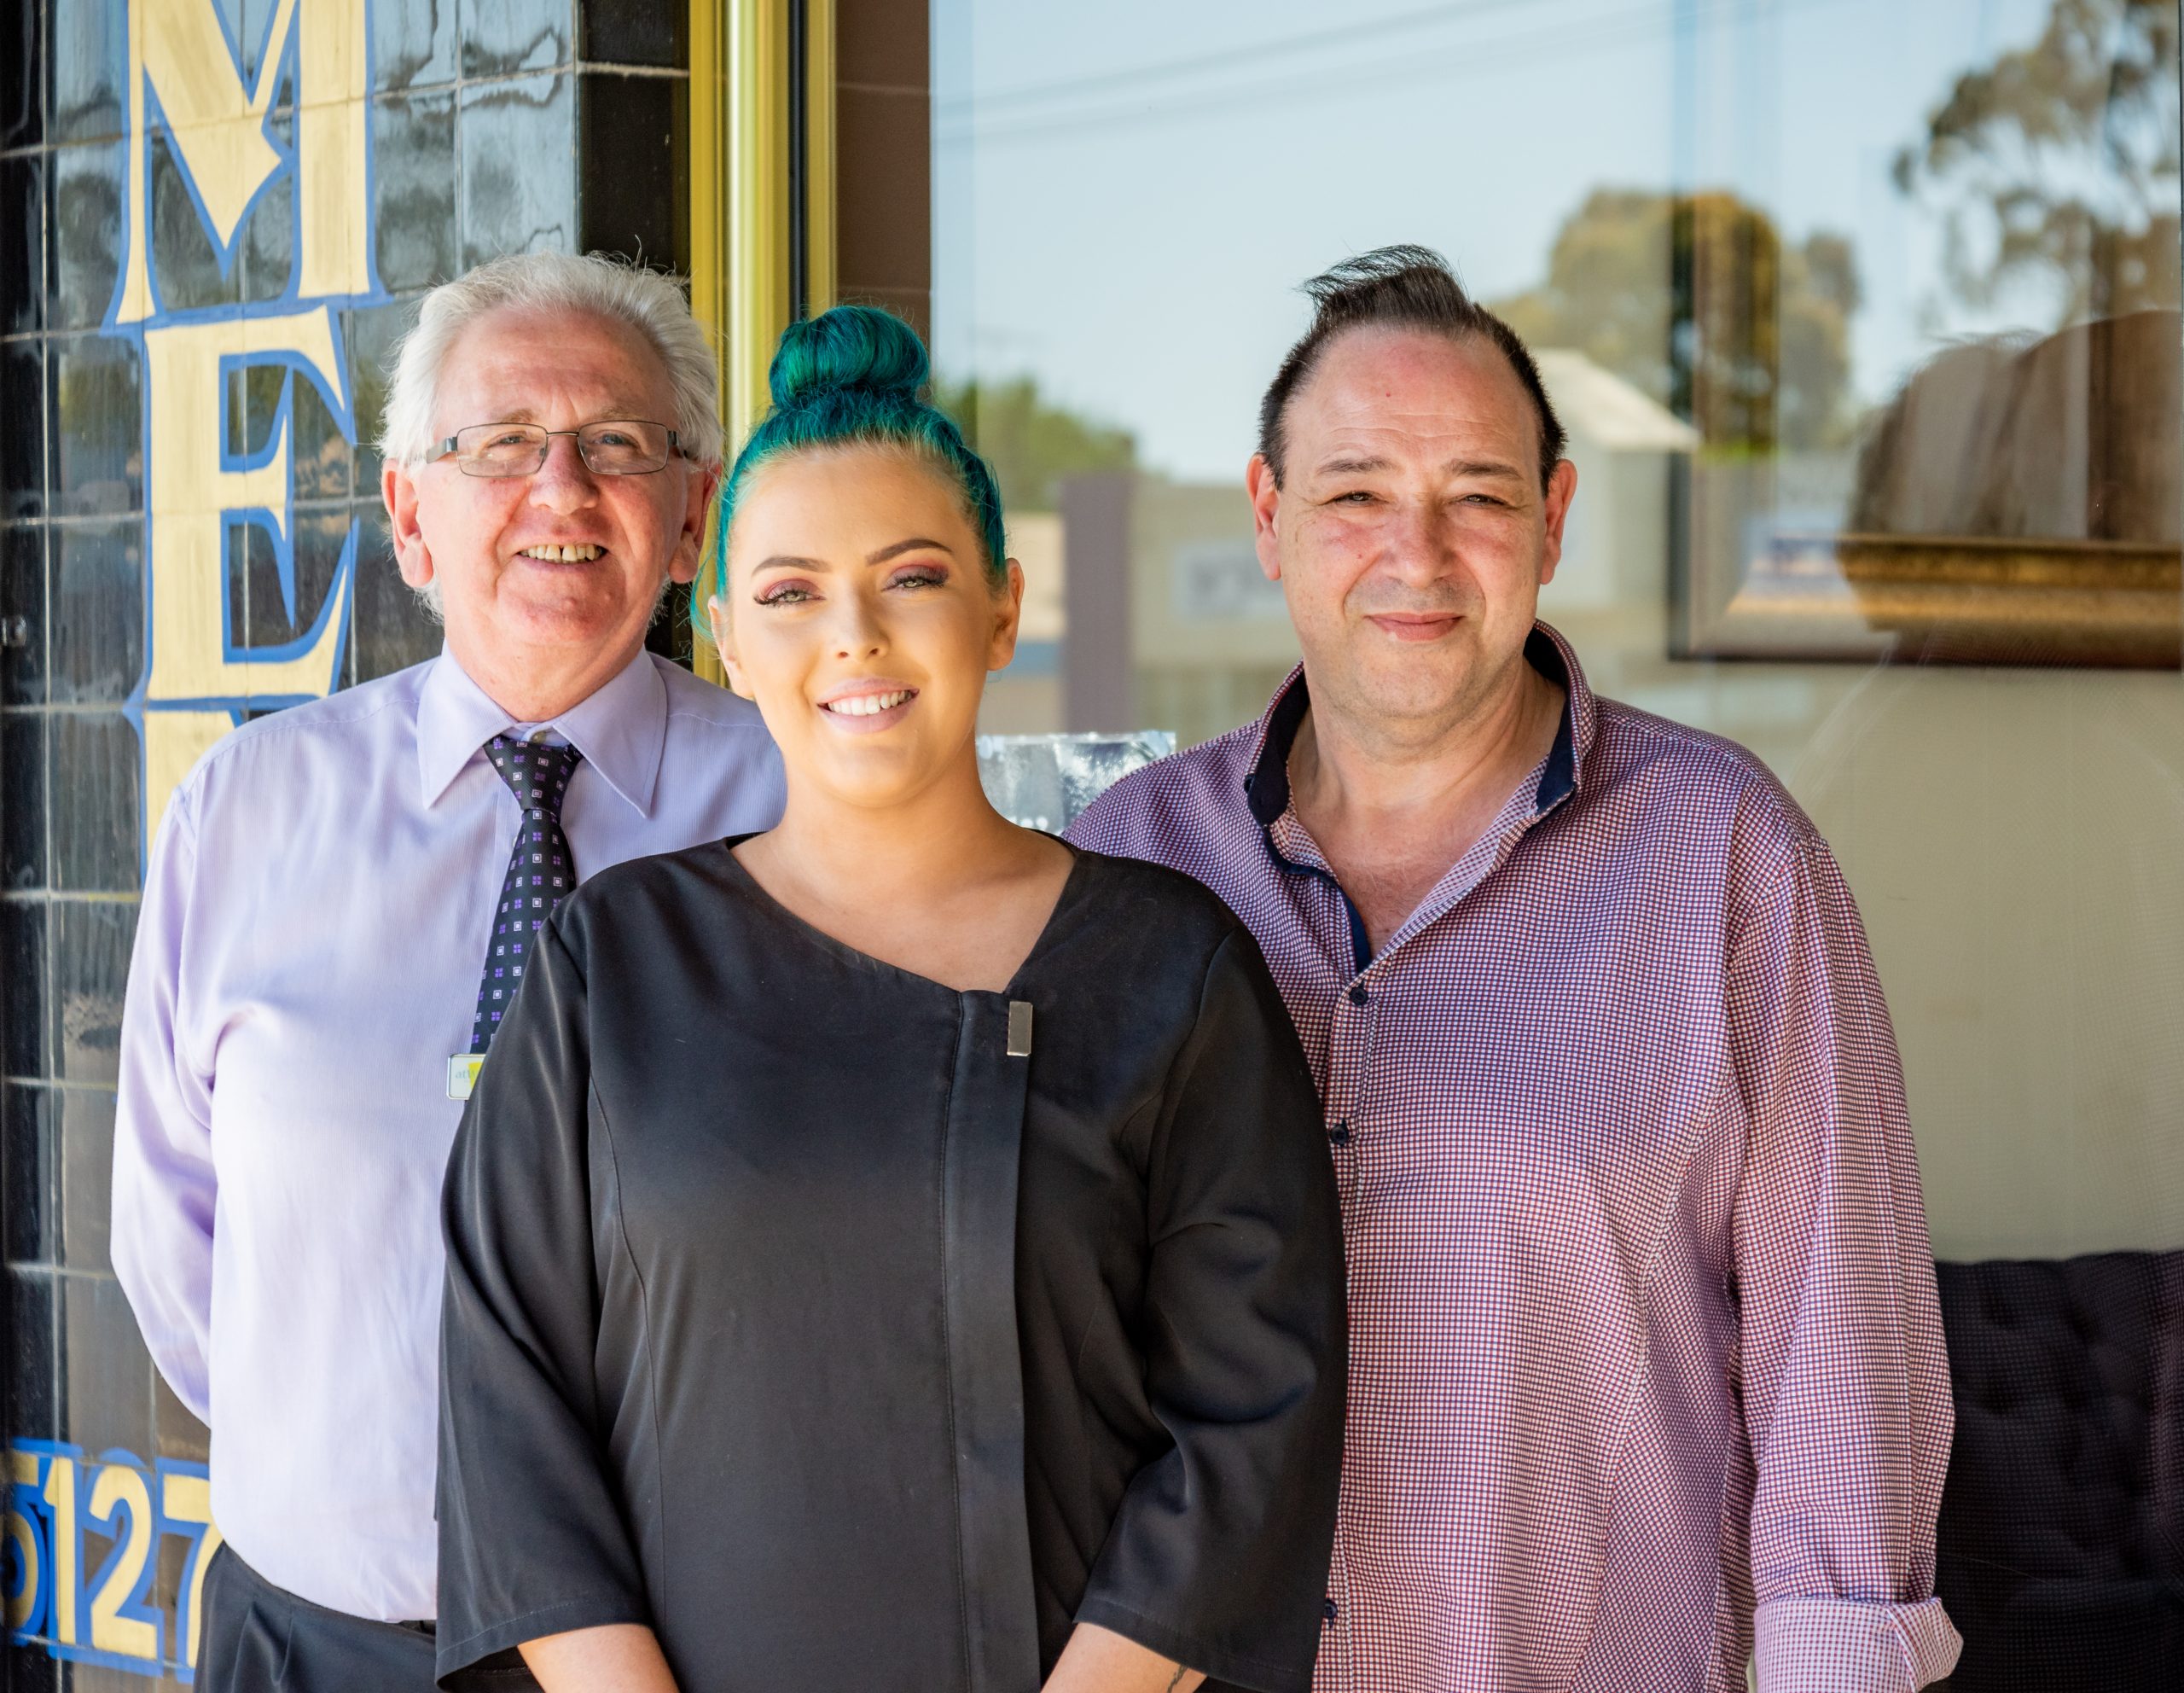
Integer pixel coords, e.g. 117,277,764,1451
1070,625,1959,1693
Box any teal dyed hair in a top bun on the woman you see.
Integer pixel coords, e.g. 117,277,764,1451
690,305,1009,629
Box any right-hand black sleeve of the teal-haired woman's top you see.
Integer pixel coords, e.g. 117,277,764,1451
1077,931,1345,1693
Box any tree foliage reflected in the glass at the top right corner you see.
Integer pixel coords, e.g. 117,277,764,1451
1896,0,2180,323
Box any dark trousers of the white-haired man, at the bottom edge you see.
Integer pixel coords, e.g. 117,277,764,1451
196,1546,437,1693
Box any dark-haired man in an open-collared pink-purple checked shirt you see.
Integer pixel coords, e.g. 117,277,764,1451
1070,247,1959,1693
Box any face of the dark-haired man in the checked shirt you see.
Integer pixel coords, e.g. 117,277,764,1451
1252,328,1577,738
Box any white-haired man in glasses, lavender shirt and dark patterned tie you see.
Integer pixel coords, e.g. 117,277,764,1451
113,253,781,1693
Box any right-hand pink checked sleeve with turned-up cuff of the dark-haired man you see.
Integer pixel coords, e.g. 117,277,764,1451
1728,841,1961,1693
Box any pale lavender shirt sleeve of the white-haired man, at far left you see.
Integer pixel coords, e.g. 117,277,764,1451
112,787,218,1422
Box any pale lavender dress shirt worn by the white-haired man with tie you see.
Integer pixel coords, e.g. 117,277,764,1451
113,653,784,1621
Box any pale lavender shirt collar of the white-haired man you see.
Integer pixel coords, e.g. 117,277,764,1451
417,647,668,817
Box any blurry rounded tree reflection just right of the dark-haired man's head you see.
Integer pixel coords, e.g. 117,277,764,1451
1494,188,1859,452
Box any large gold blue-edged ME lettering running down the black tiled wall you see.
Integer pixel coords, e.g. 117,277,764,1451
117,0,385,839
